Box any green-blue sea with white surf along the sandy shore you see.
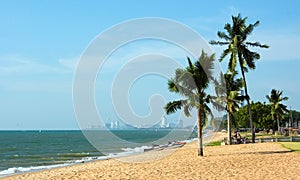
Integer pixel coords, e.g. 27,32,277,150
0,130,196,177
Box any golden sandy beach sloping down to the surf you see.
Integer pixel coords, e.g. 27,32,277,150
4,134,300,180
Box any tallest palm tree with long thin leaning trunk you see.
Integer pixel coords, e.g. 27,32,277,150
210,14,269,143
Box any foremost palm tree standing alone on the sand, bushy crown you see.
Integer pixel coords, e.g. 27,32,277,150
165,51,214,156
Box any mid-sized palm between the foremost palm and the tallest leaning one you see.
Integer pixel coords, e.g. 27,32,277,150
213,71,243,144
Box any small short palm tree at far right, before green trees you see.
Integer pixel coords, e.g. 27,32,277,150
266,89,289,134
